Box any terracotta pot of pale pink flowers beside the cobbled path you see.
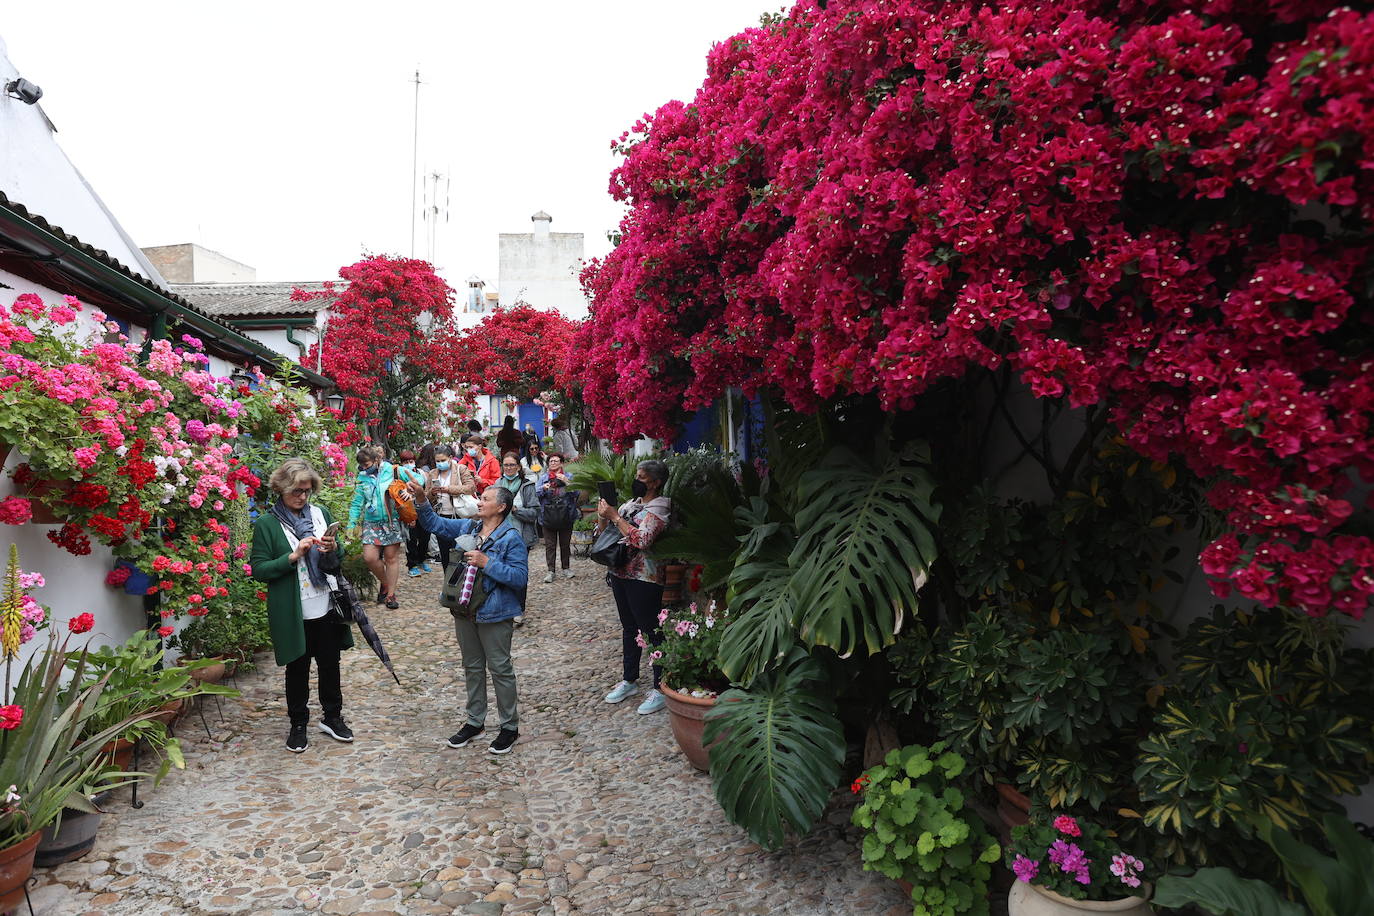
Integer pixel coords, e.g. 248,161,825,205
651,602,730,772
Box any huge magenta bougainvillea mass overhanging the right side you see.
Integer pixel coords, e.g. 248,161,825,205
573,0,1374,617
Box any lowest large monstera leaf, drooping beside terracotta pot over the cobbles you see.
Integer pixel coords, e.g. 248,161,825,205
705,648,845,849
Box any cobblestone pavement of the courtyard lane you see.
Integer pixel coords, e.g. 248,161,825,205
33,545,911,916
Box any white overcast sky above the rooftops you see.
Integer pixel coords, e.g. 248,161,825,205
0,0,785,286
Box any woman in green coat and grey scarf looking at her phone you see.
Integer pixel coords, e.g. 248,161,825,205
249,459,353,754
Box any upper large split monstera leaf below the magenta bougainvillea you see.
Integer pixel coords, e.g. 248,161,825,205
789,450,940,656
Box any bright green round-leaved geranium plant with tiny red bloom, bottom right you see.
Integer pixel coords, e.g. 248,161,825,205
851,742,1002,916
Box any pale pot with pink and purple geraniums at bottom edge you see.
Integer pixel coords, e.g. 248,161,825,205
1006,808,1153,916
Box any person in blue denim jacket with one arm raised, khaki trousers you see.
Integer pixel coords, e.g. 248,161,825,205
409,483,529,754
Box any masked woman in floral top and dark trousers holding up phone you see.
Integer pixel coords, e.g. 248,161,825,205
596,459,672,715
